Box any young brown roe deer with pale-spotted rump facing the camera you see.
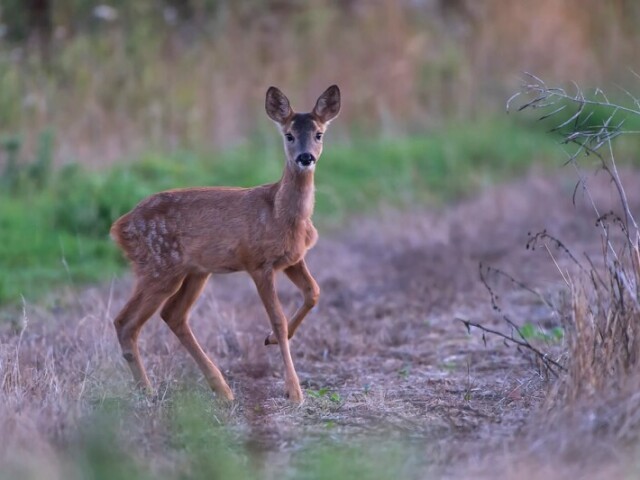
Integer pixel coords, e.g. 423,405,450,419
111,85,340,403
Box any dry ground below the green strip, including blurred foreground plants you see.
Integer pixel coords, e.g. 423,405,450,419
5,164,640,480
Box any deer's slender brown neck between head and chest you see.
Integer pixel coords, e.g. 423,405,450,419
275,165,315,226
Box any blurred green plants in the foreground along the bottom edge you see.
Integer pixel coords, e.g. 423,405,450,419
52,391,422,480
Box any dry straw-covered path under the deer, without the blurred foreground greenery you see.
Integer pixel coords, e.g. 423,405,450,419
0,173,640,477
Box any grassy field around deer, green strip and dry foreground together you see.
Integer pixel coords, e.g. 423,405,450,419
0,101,640,480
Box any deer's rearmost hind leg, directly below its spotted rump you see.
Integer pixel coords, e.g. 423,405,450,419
113,277,183,392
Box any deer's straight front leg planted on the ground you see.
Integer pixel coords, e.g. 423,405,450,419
251,269,304,403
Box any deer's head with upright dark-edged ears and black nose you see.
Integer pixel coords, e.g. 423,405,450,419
265,85,340,171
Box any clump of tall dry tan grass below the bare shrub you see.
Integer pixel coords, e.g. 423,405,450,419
536,202,640,458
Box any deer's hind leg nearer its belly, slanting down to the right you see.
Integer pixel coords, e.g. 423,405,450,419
160,273,233,401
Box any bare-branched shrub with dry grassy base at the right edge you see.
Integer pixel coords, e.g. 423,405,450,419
507,74,640,412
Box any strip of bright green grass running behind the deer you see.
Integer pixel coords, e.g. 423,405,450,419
0,120,558,303
